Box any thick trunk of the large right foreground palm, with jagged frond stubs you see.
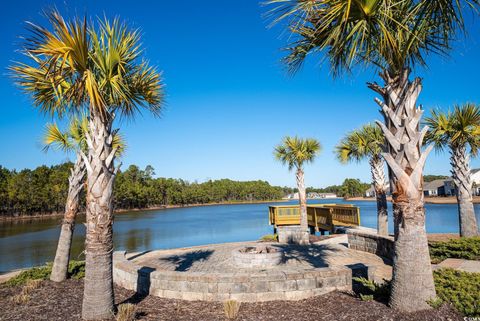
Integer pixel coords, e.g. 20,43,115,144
368,69,436,311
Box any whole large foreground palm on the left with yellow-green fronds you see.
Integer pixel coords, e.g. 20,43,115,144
11,11,163,320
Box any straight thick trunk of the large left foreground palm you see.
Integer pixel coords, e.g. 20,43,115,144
82,108,115,320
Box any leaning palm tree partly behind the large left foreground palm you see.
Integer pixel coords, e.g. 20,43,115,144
43,117,125,282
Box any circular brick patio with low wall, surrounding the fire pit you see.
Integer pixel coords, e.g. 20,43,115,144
114,242,390,302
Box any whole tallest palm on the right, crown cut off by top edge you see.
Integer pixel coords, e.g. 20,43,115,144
267,0,479,311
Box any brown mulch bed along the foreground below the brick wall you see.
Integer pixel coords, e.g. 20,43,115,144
0,280,463,321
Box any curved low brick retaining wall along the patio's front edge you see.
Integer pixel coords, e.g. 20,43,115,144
113,252,352,302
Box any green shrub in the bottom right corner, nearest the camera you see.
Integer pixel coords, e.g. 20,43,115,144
433,269,480,317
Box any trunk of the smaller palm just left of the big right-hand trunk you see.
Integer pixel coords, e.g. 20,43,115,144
370,155,388,235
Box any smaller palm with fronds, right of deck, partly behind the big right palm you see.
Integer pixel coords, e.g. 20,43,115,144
335,124,388,235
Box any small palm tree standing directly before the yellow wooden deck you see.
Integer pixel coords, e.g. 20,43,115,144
274,136,321,244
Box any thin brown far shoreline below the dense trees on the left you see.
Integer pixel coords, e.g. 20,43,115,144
0,199,290,222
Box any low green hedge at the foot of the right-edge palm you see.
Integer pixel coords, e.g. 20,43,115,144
429,237,480,263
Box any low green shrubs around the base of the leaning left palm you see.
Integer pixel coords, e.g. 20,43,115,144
6,260,85,286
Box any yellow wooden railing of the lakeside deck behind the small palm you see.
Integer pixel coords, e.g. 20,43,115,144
268,204,360,232
